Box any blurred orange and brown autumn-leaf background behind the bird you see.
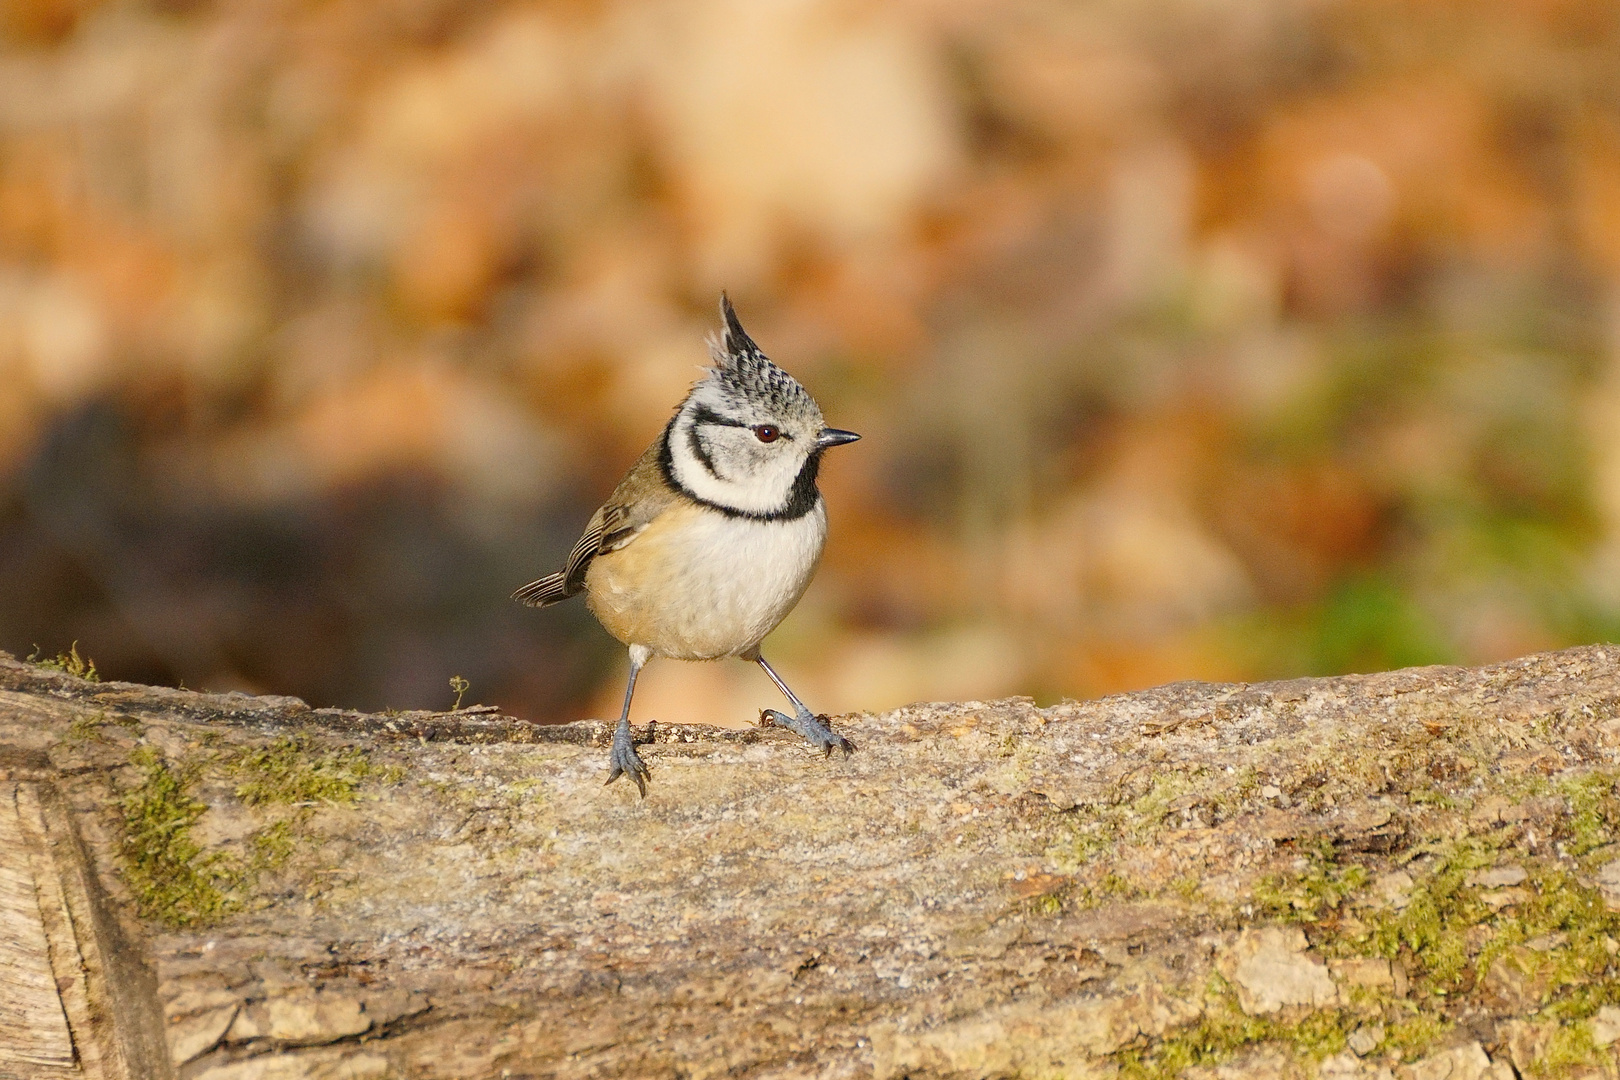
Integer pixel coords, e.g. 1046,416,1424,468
0,0,1620,724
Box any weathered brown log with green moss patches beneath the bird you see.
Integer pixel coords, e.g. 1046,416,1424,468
0,646,1620,1080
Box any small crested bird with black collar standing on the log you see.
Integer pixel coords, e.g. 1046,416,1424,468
512,293,860,798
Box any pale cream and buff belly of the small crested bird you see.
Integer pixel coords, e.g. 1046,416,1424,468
585,504,826,661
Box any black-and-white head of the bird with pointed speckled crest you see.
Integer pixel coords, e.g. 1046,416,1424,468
659,295,860,520
